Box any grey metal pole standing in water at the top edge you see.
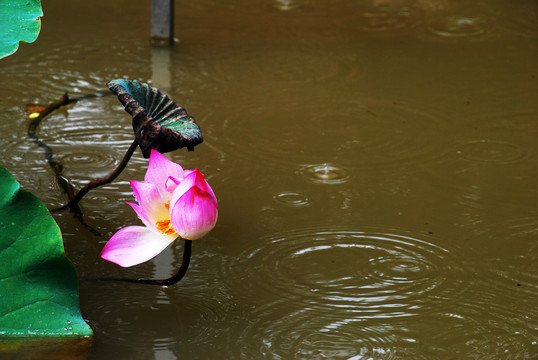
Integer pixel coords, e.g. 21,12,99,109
151,0,174,45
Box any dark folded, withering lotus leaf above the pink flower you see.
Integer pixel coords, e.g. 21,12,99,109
107,79,203,158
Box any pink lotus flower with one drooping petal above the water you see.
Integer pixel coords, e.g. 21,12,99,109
101,150,218,267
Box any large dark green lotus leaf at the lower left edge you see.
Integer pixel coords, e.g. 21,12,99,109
0,165,92,337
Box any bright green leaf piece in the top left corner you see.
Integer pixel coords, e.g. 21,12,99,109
0,0,43,59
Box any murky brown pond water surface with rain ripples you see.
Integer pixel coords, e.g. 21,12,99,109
0,0,538,359
